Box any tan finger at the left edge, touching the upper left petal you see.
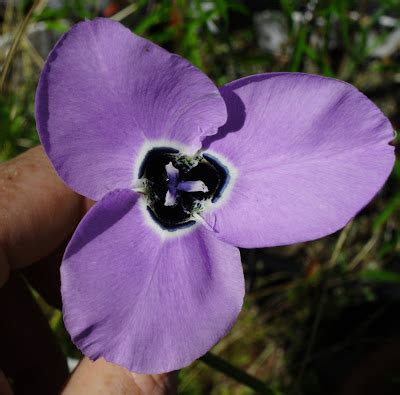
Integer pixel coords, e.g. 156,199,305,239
0,147,84,281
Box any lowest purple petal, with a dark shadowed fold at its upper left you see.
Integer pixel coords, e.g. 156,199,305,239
61,190,244,373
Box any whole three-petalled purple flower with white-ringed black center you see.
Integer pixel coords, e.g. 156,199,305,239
36,19,394,373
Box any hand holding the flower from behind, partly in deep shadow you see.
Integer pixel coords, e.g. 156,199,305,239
0,147,176,395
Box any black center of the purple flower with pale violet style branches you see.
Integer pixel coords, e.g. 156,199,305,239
139,147,229,231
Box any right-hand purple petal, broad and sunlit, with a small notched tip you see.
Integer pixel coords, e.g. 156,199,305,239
205,73,394,247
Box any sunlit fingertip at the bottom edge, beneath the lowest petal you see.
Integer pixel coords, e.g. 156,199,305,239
62,358,176,395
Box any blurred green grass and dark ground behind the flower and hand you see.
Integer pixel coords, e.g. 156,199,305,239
0,0,400,395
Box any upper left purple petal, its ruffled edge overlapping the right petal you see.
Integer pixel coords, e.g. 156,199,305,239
36,18,226,200
